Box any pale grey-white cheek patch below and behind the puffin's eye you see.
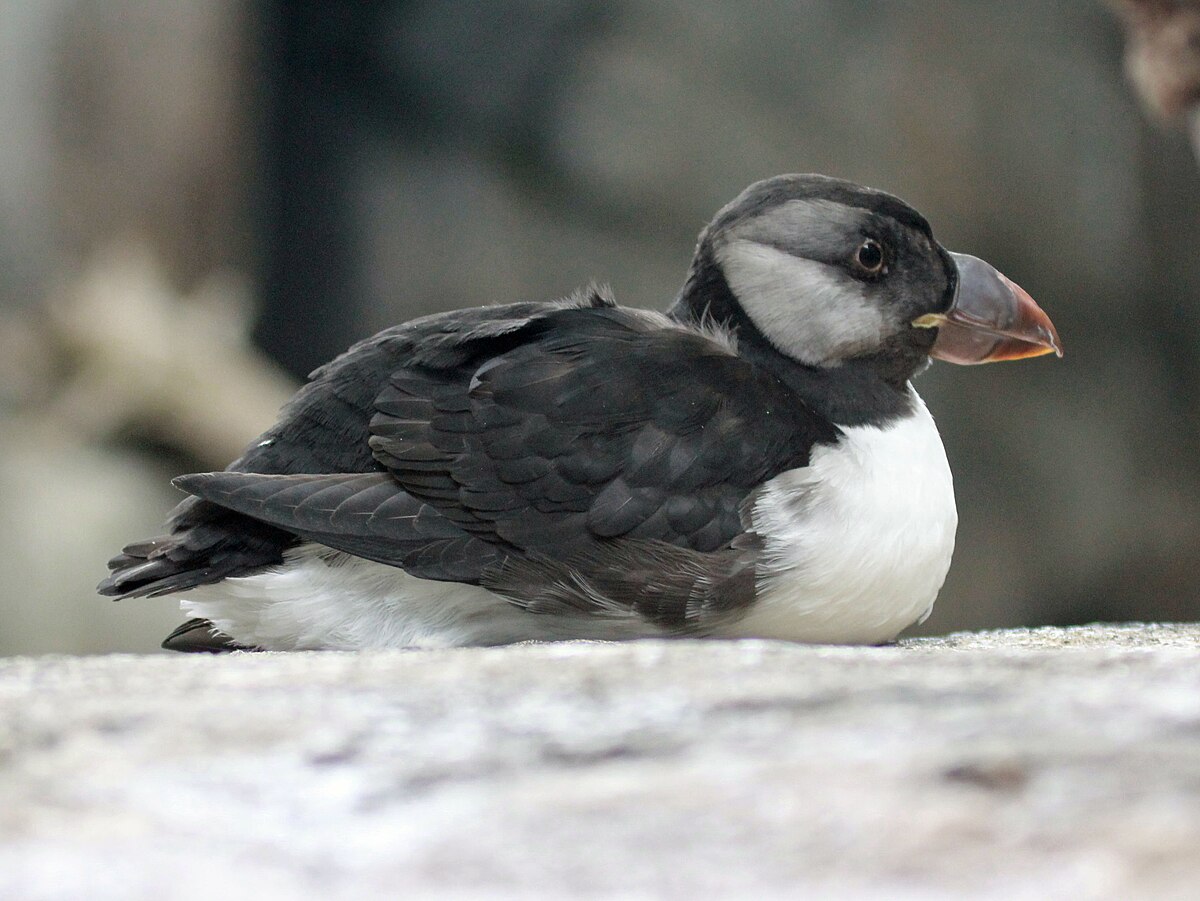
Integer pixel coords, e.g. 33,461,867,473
716,239,888,366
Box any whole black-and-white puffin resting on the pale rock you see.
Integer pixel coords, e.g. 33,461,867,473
98,174,1062,651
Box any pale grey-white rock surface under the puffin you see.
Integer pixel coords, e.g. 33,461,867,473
0,625,1200,901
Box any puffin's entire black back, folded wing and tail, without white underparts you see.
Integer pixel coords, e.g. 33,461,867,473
110,299,836,629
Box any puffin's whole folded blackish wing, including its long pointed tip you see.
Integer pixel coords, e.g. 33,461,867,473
182,308,836,627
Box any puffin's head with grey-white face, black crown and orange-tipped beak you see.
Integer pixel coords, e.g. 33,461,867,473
679,175,1062,382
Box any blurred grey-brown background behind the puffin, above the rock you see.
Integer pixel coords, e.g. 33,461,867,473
0,0,1200,654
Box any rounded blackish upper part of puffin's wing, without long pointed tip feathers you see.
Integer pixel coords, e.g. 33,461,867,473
371,310,836,558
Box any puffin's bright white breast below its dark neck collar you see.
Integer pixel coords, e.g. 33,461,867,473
721,389,958,644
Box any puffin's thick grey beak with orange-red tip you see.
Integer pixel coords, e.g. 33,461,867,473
912,253,1062,365
